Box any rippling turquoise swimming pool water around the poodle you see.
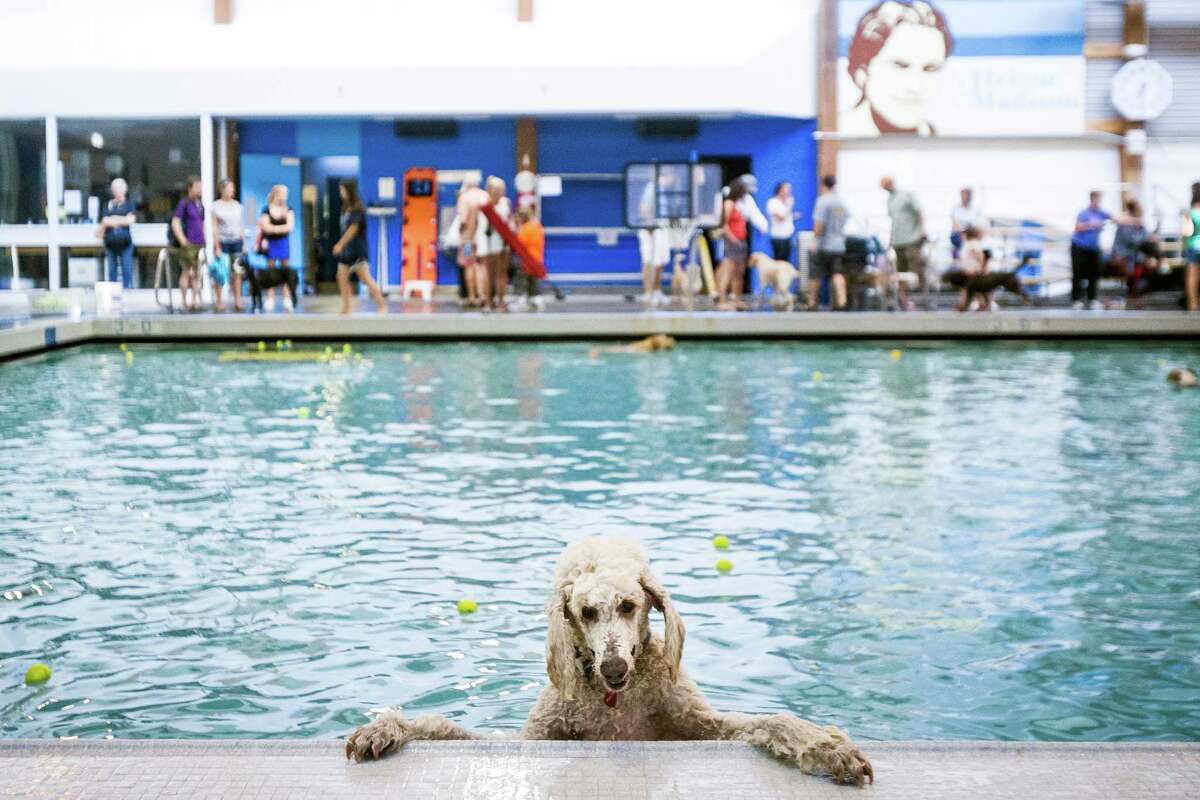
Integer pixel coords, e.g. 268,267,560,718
0,343,1200,740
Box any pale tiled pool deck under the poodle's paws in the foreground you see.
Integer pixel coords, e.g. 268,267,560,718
0,740,1200,800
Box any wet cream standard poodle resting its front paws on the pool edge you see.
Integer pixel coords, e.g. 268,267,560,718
346,539,874,786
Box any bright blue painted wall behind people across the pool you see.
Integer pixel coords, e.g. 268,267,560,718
239,118,817,284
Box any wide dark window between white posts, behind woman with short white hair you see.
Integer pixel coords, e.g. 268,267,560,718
59,119,200,223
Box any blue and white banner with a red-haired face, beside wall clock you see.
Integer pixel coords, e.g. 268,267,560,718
838,0,1086,137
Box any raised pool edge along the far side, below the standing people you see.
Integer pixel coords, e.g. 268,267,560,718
0,311,1200,360
